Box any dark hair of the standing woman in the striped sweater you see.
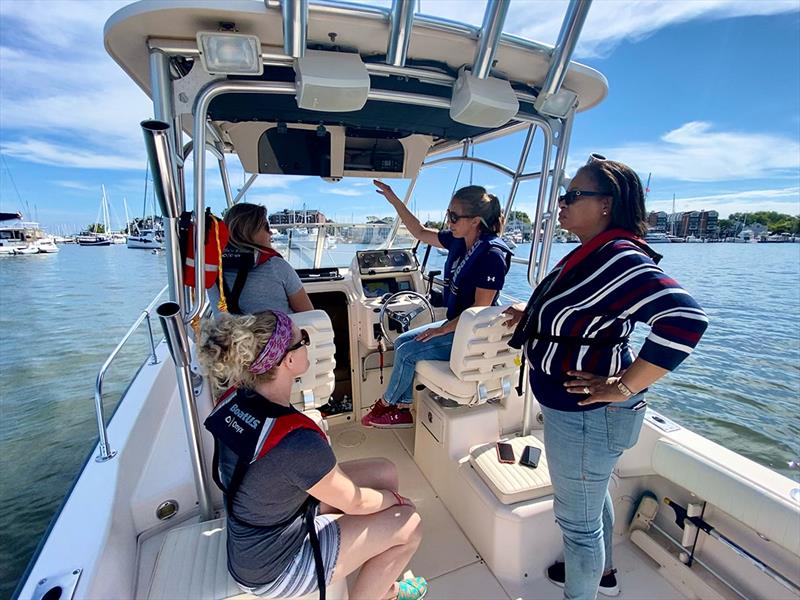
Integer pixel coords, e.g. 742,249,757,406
579,154,647,237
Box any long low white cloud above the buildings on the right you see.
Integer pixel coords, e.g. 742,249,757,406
569,121,800,182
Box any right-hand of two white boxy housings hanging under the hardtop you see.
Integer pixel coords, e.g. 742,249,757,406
450,68,519,127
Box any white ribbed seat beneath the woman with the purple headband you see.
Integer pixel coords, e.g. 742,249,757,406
147,518,347,600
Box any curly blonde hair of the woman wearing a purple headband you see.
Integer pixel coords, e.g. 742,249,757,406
197,311,277,398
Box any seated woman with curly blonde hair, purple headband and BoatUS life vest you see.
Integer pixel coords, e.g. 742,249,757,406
199,311,427,600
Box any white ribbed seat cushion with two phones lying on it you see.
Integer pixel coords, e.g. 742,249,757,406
469,435,553,504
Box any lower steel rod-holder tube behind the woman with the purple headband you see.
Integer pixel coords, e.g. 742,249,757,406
156,302,214,521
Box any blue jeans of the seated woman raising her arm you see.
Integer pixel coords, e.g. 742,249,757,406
383,321,455,404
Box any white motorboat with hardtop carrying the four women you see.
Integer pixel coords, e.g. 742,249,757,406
17,0,800,600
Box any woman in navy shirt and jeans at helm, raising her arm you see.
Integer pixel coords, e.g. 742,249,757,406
361,181,511,428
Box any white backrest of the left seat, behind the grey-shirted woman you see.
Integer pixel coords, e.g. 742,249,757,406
291,310,336,411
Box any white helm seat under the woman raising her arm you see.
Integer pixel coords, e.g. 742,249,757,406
416,306,520,405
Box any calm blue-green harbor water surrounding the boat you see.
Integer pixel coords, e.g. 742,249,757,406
0,244,800,597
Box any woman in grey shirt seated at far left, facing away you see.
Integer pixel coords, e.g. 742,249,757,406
209,203,314,314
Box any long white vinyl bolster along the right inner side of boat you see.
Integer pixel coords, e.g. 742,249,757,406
652,438,800,555
